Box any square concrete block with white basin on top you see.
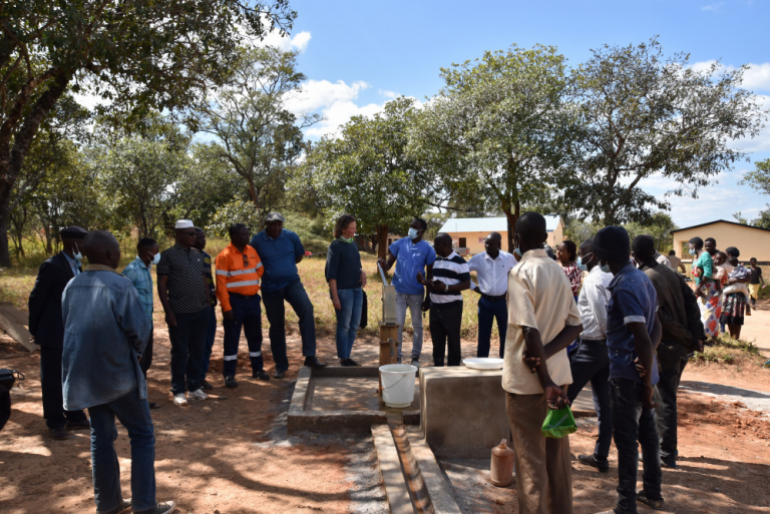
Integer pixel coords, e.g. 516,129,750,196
420,367,510,459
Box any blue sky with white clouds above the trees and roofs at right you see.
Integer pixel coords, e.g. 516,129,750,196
258,0,770,227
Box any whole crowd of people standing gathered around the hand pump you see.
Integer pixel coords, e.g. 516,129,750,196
22,208,764,514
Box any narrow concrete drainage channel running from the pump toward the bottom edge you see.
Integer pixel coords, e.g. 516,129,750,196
372,420,460,514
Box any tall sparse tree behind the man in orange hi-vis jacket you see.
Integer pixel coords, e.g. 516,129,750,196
185,47,319,219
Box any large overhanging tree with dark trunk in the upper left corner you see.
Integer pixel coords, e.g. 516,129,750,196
0,0,296,266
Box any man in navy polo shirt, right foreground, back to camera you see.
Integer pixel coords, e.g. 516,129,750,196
593,227,663,514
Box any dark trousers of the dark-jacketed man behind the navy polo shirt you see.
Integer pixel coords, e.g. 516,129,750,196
655,344,687,461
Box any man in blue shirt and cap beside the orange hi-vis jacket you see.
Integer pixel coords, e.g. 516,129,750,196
251,212,326,378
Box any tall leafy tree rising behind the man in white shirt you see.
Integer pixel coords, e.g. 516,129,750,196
412,45,569,251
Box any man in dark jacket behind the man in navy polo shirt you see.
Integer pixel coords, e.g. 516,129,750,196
633,236,706,468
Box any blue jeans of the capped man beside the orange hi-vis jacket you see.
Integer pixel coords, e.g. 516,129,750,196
262,280,316,371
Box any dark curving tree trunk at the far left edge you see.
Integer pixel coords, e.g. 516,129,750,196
0,73,69,266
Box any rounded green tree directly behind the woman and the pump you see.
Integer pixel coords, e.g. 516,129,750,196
295,97,437,257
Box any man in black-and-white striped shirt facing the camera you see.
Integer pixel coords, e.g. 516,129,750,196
417,232,471,366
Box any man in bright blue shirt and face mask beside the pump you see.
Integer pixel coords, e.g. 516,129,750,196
379,218,436,367
